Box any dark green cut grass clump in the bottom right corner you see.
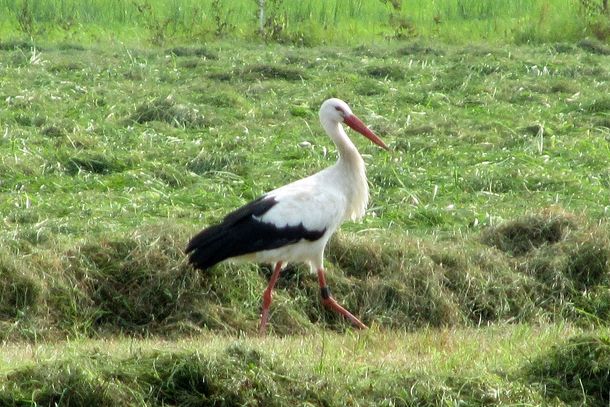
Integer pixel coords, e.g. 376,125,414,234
524,334,610,407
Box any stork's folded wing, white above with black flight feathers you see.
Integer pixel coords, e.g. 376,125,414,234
186,171,347,269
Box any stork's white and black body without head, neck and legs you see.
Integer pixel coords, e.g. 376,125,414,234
187,150,368,271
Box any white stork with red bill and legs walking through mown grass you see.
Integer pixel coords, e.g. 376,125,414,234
186,99,388,334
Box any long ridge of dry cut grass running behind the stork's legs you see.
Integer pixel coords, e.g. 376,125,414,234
2,212,610,338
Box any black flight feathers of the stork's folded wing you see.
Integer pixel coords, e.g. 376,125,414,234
186,196,326,270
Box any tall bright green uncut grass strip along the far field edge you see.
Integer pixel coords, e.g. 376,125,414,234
0,0,610,45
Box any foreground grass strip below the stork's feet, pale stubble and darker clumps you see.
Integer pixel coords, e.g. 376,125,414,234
0,325,610,406
